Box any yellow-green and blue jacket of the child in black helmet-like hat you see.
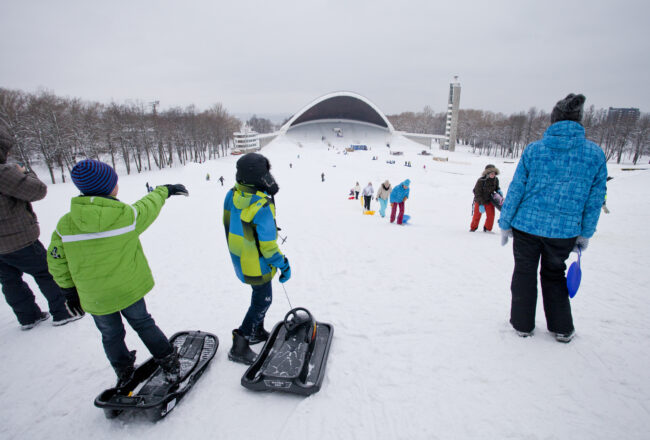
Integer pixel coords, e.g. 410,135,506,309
223,184,284,285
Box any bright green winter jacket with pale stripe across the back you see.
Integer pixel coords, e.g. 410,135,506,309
47,186,167,315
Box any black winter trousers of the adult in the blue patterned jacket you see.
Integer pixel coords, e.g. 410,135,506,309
510,228,576,334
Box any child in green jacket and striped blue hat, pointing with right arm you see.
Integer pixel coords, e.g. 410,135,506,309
47,160,188,388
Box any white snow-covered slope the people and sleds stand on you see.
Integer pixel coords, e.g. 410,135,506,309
0,136,650,440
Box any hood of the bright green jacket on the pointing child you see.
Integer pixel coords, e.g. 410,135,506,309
70,196,133,233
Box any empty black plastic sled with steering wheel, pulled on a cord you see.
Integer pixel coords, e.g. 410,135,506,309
241,307,334,396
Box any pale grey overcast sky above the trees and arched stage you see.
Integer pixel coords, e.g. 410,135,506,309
0,0,650,118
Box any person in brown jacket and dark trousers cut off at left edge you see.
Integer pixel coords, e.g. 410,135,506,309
0,133,84,330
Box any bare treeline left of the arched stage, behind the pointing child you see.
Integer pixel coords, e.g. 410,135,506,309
0,88,241,183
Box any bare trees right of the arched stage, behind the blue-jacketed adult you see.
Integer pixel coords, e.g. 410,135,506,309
388,106,650,164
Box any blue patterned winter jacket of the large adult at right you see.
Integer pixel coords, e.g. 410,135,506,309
499,121,607,238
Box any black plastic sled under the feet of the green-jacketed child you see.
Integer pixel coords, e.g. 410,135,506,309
95,331,219,421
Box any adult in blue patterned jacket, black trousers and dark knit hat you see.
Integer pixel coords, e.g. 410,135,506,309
499,94,607,342
